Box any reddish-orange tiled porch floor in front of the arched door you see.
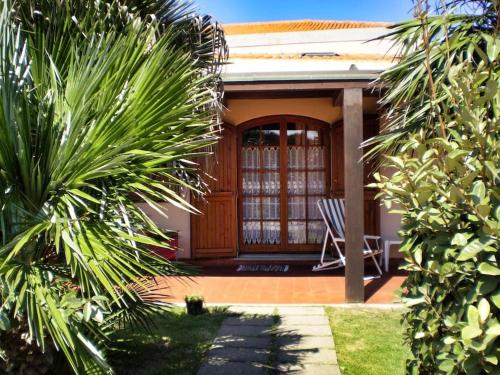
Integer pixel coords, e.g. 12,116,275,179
156,265,405,304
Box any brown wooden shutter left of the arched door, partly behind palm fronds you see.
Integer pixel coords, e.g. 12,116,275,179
191,125,238,258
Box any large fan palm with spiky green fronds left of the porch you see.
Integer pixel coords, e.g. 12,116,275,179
0,0,226,374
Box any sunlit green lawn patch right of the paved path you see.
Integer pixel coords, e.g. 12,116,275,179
326,307,410,375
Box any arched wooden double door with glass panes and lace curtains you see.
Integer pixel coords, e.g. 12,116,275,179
238,116,330,253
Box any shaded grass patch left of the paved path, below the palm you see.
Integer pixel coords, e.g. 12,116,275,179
111,308,231,375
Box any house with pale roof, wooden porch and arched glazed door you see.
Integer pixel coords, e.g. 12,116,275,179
139,20,399,299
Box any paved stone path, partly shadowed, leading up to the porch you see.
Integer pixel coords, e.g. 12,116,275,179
198,306,340,375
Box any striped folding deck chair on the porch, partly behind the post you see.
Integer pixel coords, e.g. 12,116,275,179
313,199,384,279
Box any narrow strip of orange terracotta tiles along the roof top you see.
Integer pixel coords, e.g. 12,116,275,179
224,20,391,35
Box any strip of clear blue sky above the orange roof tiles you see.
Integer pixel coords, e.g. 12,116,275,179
194,0,412,23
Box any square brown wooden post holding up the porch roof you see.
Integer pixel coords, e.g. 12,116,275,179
343,88,365,303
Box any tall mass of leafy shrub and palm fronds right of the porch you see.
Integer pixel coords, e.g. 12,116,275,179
375,1,500,374
